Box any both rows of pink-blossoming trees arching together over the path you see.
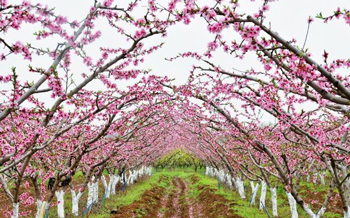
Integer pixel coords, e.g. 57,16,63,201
0,0,350,218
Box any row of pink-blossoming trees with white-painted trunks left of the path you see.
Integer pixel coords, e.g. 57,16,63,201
0,0,180,218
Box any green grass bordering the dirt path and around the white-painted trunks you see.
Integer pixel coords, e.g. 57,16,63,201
43,168,341,218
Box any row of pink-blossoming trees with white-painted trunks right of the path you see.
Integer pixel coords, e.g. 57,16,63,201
169,1,350,217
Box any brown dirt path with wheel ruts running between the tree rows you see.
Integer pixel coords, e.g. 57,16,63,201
113,177,241,218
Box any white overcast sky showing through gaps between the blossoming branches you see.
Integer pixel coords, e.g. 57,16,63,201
0,0,350,120
